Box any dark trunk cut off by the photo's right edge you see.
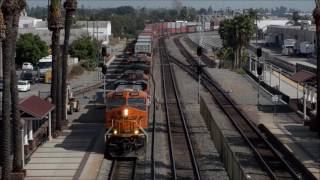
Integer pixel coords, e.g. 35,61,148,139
311,0,320,135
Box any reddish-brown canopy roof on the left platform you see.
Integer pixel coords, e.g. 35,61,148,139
18,95,54,119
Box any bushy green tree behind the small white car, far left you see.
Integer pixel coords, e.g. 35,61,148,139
16,33,49,64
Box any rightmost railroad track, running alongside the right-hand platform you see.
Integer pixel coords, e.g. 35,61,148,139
169,36,316,179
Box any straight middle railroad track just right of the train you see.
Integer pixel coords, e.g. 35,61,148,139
160,39,201,179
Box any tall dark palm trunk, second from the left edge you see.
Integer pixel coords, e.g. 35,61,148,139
10,0,26,172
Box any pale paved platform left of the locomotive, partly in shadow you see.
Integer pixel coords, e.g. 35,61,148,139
25,83,104,180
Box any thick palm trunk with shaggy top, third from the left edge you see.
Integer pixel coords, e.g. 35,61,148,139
48,0,62,135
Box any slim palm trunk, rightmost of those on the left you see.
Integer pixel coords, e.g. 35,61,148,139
62,0,77,124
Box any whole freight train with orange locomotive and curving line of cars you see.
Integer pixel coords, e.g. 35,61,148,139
105,21,214,158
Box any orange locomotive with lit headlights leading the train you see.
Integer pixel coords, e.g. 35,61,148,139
105,87,149,157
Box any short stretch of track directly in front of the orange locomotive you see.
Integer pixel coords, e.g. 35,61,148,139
108,159,137,180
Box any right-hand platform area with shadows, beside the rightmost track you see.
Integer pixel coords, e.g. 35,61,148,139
207,68,320,178
